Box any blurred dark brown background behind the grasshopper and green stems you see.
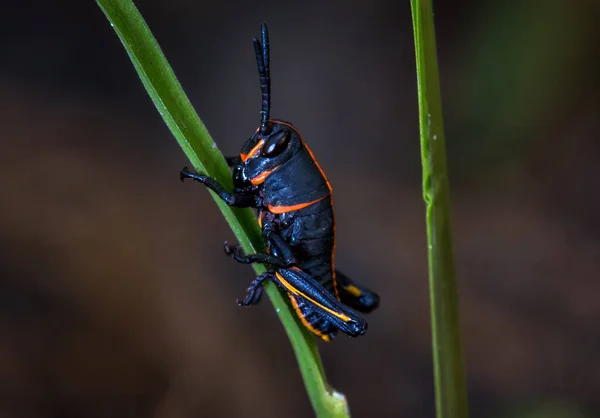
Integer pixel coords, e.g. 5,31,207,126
0,0,600,418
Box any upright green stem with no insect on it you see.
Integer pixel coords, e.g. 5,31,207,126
411,0,468,418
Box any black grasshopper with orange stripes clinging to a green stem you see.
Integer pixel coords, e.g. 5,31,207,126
181,24,379,341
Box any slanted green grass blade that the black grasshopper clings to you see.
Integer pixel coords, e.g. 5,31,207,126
96,0,349,417
